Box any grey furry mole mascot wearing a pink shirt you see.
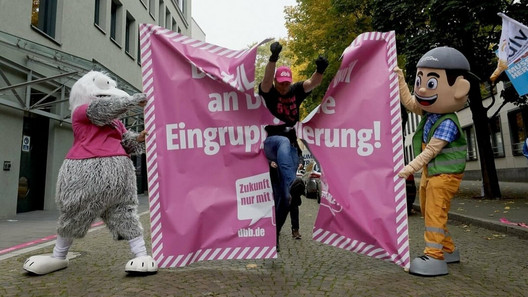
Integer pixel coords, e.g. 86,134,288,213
24,71,158,275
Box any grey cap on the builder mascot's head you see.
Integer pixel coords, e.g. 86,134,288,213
416,46,469,71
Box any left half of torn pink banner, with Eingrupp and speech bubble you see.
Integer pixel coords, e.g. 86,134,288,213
140,24,277,268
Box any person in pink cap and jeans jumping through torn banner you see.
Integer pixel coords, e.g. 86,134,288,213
259,42,328,251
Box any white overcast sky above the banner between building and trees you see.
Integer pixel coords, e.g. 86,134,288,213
192,0,296,50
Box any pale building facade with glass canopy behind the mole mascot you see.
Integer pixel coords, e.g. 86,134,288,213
0,0,205,218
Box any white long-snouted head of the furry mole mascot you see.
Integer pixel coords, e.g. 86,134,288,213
70,71,129,113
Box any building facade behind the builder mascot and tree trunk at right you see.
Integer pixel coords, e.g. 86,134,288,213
404,83,528,182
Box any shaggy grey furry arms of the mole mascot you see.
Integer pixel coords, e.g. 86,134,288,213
86,93,145,154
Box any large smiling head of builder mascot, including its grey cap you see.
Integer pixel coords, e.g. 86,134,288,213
414,46,470,114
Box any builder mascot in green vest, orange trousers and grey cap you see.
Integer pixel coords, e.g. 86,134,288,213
395,47,470,276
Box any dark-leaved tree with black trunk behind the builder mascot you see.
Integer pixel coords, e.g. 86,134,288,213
372,0,527,198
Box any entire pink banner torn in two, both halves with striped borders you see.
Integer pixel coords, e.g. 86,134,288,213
140,25,409,268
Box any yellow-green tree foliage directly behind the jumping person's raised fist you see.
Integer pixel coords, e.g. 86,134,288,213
285,0,372,116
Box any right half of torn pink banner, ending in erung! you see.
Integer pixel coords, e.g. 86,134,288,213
297,32,409,268
